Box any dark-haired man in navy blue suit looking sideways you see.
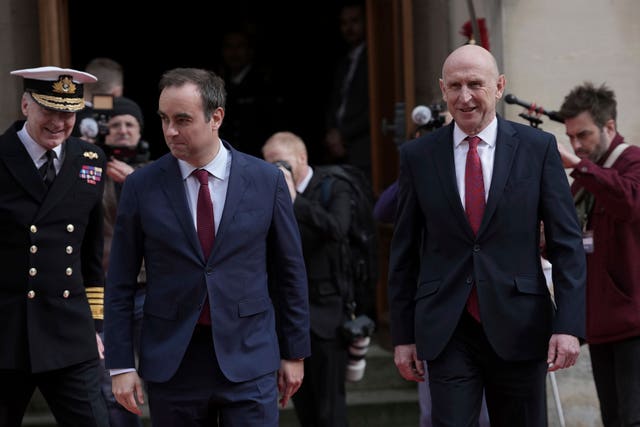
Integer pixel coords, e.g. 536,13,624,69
105,68,310,427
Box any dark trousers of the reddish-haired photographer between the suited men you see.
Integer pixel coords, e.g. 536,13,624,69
292,333,348,427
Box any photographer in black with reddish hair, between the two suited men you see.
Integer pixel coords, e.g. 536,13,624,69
262,132,352,427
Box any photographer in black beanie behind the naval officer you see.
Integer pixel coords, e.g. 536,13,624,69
96,97,150,427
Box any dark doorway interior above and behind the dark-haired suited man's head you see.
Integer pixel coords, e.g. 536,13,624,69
69,0,344,163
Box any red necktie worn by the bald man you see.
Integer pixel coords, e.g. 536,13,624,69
464,136,485,322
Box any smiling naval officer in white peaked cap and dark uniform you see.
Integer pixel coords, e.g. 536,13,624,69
0,67,108,427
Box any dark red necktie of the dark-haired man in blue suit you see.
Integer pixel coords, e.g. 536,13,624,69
193,169,215,325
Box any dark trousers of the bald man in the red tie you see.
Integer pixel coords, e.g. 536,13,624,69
427,310,547,427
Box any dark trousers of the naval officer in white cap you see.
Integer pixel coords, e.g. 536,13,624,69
0,359,109,427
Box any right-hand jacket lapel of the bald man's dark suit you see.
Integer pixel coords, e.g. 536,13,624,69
478,117,520,234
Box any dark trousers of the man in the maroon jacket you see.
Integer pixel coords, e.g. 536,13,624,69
589,336,640,427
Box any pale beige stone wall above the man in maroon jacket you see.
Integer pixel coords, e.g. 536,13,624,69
502,0,640,144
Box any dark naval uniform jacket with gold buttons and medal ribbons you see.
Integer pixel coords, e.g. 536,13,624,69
0,121,105,373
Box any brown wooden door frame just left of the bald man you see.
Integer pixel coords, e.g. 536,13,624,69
366,0,416,330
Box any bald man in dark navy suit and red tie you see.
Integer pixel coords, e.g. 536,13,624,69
388,45,586,427
